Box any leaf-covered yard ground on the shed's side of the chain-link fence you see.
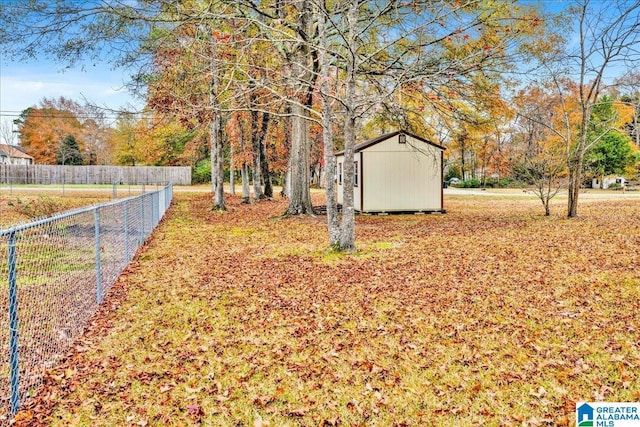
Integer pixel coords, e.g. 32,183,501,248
16,194,640,427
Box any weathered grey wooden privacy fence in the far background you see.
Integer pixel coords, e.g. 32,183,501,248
0,164,191,185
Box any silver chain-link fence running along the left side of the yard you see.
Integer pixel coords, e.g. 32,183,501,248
0,184,173,425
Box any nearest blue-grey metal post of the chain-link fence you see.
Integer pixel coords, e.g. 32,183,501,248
7,231,20,415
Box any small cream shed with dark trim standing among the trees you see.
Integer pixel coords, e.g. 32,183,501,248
336,131,445,213
